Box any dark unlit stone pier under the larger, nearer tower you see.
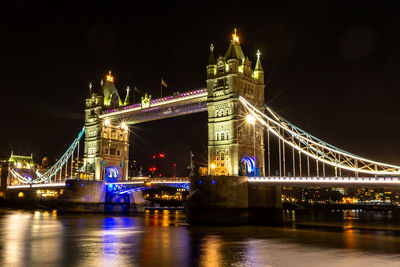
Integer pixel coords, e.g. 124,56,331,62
186,176,282,225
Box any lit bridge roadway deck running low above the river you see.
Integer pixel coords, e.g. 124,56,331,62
7,176,400,190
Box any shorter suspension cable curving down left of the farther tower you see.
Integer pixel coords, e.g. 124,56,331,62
10,127,85,184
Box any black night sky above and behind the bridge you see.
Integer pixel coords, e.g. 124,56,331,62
0,0,400,176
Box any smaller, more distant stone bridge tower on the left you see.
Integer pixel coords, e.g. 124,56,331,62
84,71,129,180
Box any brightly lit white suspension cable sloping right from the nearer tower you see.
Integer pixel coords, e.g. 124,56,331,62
239,96,400,176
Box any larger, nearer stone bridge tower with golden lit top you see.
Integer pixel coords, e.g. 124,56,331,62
207,29,265,176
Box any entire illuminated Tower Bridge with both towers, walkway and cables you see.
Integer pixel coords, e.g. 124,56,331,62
8,29,400,223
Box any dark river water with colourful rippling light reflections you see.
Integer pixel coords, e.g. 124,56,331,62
0,210,400,267
